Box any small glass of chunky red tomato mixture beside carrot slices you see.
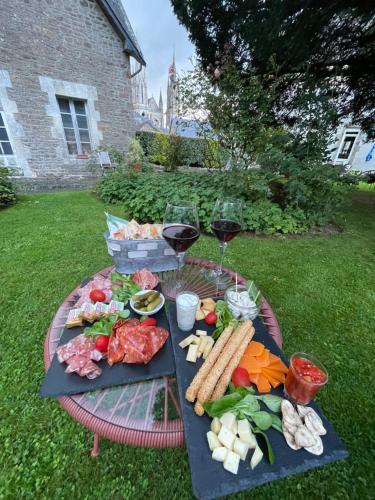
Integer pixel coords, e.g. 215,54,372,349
284,352,328,405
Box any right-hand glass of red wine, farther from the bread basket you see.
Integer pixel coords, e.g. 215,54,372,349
207,198,243,288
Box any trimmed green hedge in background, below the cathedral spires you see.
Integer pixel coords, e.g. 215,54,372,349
136,131,228,171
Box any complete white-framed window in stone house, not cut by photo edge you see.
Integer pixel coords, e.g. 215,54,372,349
57,97,91,155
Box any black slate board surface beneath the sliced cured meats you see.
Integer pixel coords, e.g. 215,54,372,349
40,296,175,398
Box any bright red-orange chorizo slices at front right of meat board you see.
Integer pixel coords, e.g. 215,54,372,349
108,319,169,366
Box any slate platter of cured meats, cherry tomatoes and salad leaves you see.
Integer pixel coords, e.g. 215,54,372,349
40,270,175,397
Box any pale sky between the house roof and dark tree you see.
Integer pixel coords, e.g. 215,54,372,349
122,0,195,106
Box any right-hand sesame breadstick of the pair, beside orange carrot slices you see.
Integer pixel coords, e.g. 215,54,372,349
197,320,253,412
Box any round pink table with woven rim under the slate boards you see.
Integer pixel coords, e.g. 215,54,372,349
44,257,282,457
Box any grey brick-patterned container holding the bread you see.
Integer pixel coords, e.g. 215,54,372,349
104,231,177,274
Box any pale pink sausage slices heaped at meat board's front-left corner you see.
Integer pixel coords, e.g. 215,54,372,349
56,334,103,379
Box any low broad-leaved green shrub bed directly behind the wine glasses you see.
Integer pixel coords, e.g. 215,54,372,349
99,172,308,234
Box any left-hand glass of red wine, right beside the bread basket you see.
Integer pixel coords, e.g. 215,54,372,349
163,201,199,291
